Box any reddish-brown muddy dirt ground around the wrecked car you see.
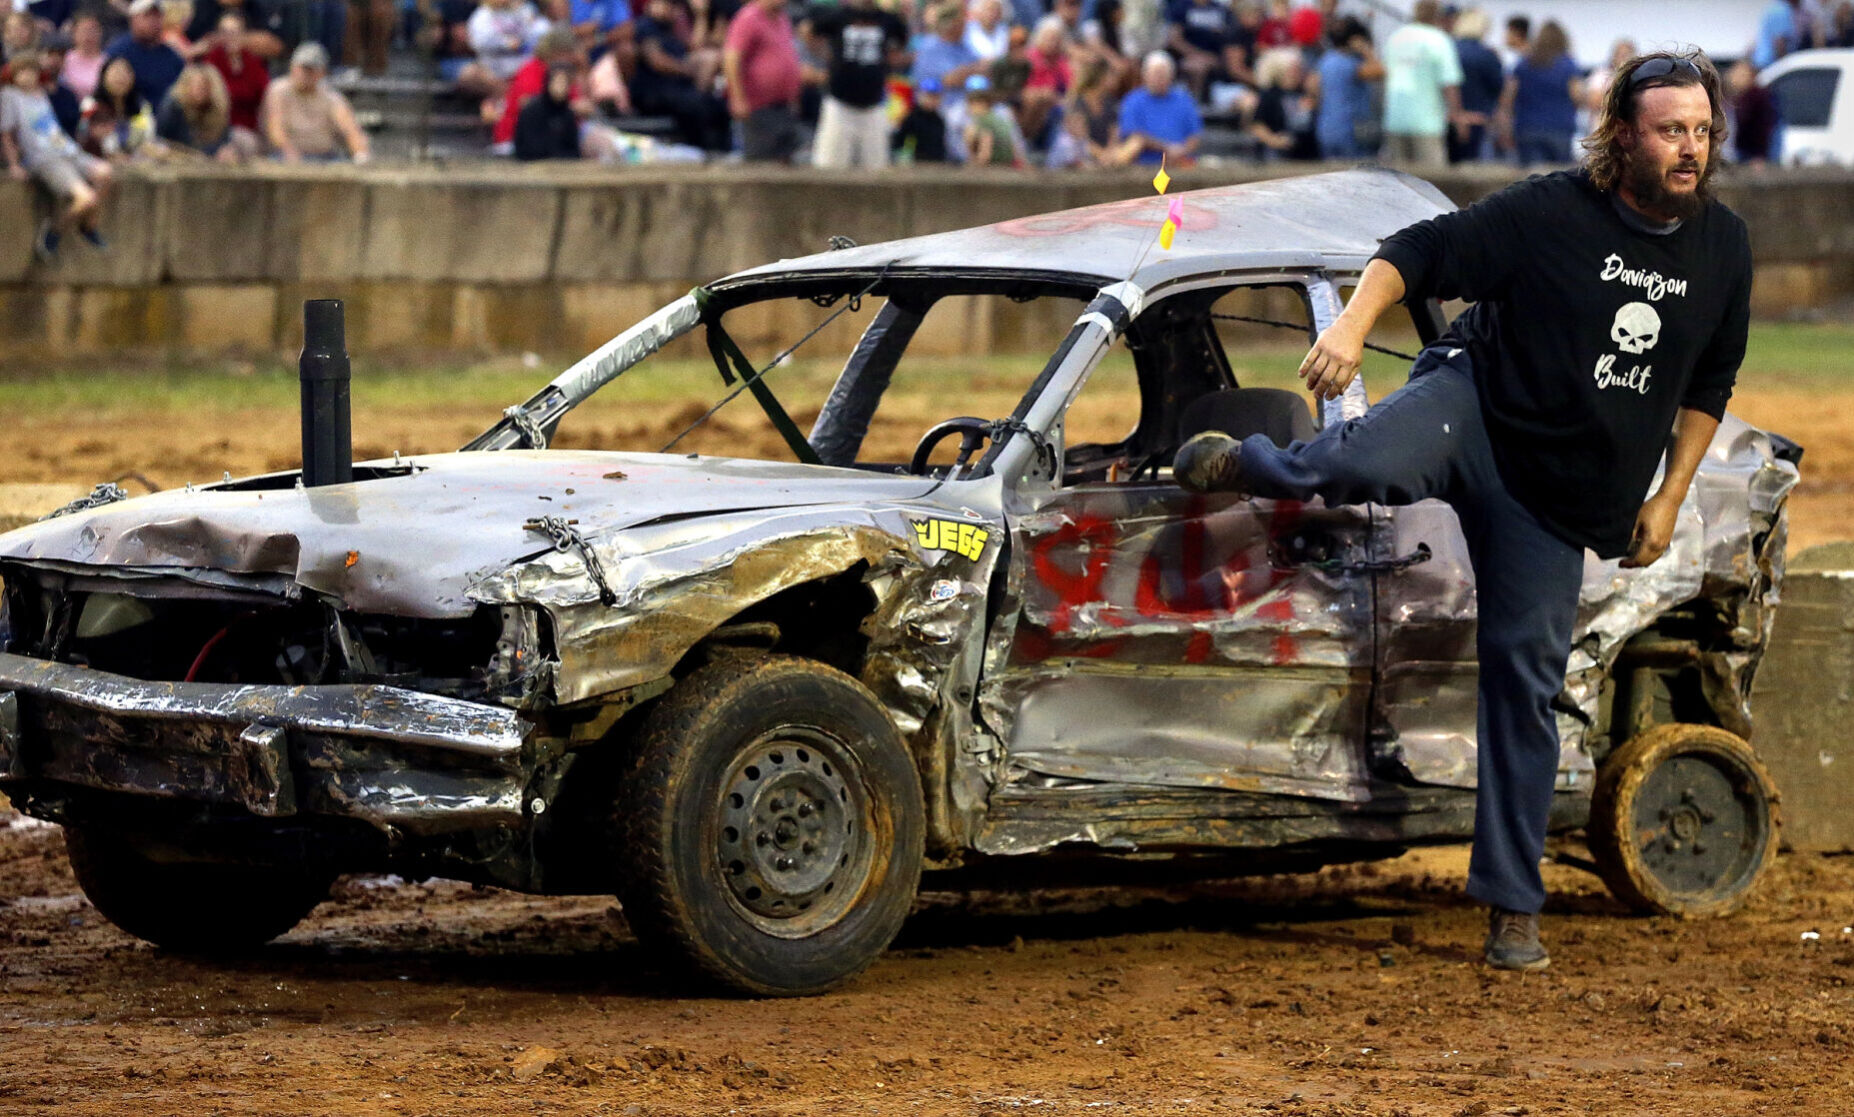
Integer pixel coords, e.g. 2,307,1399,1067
0,380,1854,1117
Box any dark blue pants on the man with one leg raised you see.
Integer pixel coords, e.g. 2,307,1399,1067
1242,347,1583,911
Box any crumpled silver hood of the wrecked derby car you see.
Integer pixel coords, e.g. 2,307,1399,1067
0,451,934,616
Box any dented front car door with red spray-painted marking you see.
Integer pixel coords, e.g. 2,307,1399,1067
981,484,1372,800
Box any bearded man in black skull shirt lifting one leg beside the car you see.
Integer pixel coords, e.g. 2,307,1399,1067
1174,54,1750,970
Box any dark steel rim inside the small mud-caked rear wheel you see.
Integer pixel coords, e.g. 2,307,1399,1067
1630,751,1771,898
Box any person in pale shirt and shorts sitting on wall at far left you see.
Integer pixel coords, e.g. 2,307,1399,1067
0,50,109,262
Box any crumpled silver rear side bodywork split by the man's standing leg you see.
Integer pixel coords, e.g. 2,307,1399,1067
1374,416,1797,790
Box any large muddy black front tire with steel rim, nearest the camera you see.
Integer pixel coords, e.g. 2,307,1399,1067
614,657,925,996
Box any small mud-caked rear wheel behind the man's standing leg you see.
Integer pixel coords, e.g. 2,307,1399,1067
1587,725,1778,918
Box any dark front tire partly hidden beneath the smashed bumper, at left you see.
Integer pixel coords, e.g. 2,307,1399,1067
65,826,332,954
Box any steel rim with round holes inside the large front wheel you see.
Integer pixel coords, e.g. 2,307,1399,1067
710,725,875,939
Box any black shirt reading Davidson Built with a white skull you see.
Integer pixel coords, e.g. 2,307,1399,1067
1378,171,1752,559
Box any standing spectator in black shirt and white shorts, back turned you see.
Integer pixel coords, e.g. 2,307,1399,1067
806,0,908,169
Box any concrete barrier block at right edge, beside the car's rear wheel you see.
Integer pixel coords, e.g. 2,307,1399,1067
1752,556,1854,852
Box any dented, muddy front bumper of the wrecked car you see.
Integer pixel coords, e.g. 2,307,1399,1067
0,653,528,831
